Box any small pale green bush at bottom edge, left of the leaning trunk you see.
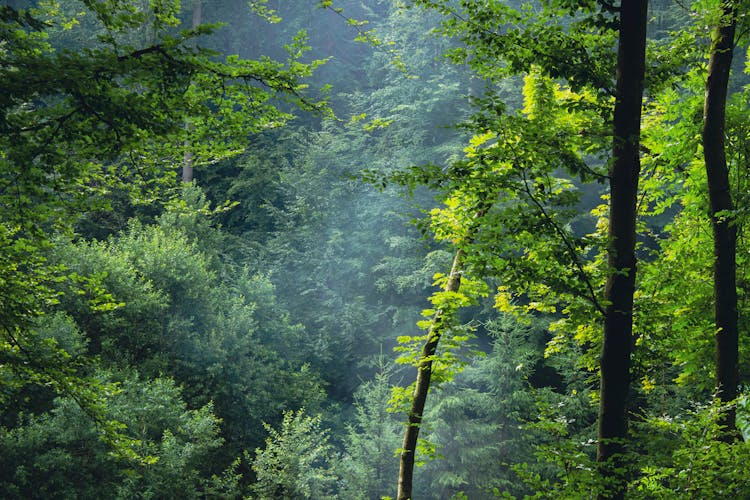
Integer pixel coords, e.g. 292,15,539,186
253,409,337,499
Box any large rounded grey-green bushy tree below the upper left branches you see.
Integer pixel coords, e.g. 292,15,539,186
52,195,320,450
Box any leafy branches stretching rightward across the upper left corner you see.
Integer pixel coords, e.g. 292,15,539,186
0,2,324,238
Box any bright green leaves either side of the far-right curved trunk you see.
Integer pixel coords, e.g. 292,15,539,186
636,34,750,398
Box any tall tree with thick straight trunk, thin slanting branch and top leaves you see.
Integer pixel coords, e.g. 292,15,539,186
388,1,647,498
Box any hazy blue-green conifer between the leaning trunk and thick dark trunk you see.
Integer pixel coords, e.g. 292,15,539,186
415,315,542,498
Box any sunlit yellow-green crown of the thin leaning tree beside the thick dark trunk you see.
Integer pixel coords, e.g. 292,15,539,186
391,68,606,369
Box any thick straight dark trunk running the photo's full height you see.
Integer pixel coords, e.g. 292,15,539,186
597,0,648,499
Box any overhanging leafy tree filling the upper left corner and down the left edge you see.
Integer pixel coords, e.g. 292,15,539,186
0,0,322,454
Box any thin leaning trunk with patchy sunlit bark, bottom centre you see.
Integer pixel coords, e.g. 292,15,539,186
396,250,464,500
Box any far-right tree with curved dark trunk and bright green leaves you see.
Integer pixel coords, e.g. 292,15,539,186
637,2,747,448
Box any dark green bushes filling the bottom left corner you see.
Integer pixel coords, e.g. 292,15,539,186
0,376,236,498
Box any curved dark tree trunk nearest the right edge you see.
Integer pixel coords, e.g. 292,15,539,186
703,0,739,440
